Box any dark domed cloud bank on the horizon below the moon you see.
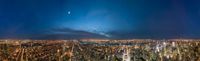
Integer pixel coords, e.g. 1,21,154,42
30,28,107,39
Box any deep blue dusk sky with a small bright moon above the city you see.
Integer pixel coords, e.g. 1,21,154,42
0,0,200,39
